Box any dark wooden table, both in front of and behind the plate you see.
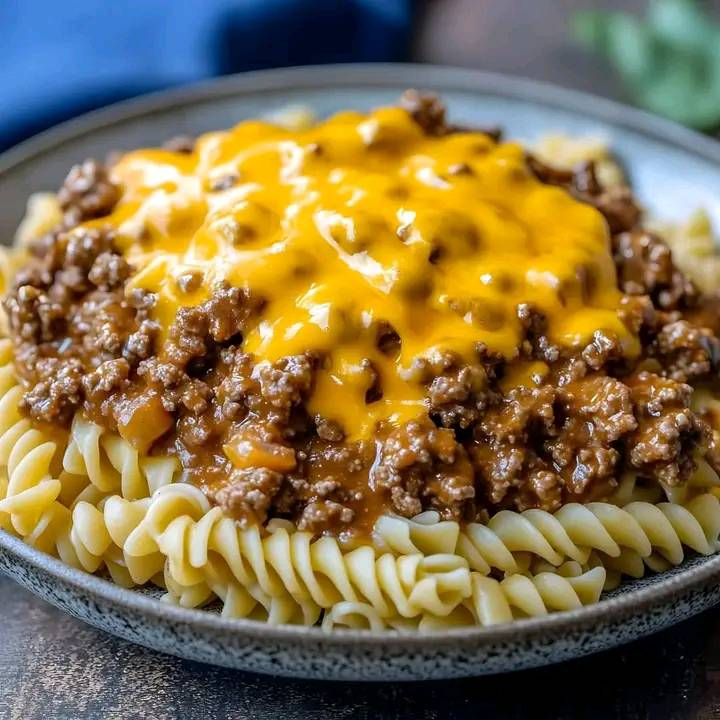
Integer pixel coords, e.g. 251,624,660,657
0,0,720,720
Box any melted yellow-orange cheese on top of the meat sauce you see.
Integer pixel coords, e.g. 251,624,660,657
90,108,634,439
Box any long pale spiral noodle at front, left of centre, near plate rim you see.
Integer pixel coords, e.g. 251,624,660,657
98,484,478,617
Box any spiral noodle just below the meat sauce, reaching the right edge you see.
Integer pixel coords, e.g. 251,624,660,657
376,493,720,592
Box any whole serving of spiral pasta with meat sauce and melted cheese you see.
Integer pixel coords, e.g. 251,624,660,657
0,93,720,632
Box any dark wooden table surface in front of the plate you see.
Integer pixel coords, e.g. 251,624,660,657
0,578,720,720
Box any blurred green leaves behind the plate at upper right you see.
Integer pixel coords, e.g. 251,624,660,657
572,0,720,131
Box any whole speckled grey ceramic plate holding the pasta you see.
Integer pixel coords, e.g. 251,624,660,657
0,65,720,680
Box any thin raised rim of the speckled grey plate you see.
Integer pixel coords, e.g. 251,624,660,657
0,63,720,651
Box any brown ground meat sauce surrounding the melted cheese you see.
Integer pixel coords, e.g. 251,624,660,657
5,94,720,536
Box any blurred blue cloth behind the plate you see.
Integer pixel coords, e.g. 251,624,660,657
0,0,411,149
